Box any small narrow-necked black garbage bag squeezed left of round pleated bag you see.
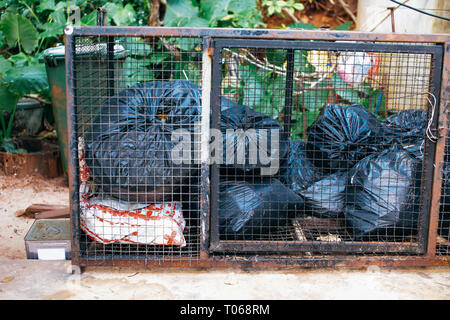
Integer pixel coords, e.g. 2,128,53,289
280,139,322,193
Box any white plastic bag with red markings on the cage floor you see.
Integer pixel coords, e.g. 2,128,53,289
78,138,186,247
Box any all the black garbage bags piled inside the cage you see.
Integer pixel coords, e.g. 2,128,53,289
81,80,440,245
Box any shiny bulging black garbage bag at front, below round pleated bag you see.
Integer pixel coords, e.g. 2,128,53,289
344,146,421,240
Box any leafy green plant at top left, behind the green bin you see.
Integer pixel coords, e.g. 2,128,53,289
0,0,139,152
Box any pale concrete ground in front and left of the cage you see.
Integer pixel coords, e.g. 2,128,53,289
0,176,450,300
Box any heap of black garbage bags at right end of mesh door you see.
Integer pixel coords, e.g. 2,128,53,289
282,105,427,241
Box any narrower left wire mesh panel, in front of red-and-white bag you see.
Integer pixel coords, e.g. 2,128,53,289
73,36,202,260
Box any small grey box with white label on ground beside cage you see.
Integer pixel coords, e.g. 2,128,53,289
25,219,71,260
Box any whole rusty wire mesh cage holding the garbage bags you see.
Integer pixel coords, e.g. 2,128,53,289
65,26,450,268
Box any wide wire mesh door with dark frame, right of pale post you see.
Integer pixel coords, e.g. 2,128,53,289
211,40,442,254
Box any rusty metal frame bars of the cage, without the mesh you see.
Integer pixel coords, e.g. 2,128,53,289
65,26,450,269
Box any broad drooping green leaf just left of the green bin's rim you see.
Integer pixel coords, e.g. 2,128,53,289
5,64,48,96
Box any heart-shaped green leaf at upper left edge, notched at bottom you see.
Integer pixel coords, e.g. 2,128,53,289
0,12,39,53
